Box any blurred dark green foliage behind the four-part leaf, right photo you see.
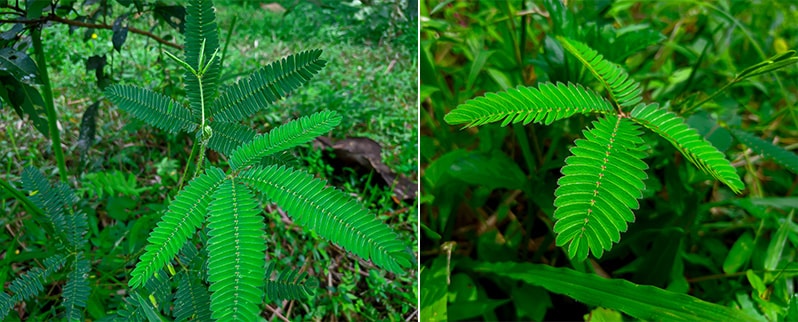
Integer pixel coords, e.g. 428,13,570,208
420,0,798,321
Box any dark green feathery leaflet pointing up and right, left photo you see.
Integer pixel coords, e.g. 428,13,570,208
211,49,326,122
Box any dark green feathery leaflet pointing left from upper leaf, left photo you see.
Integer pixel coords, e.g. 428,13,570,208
105,85,197,133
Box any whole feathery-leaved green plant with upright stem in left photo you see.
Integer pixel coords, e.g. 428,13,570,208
106,0,414,321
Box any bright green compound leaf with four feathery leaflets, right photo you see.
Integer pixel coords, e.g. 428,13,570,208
444,37,744,260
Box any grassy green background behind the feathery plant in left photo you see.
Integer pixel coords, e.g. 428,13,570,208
0,1,418,320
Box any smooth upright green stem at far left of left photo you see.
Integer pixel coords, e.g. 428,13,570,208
31,27,67,182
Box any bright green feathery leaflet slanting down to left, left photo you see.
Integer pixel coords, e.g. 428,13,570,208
129,168,225,288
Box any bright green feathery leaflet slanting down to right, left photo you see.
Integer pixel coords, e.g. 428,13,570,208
239,166,414,273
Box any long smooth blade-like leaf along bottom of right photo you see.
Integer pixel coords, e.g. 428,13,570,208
469,262,754,321
